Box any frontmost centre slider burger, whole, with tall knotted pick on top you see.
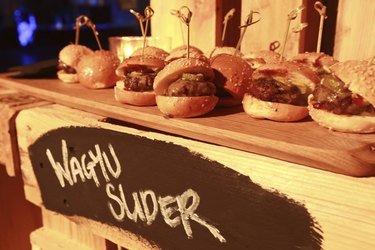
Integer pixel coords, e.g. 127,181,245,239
154,58,218,117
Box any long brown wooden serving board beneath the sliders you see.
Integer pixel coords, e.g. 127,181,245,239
0,75,375,176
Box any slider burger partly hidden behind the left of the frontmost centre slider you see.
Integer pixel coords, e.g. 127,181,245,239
114,55,165,106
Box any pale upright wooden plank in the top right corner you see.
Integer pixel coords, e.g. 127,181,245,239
334,0,375,61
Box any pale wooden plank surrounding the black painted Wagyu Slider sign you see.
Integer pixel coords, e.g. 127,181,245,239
17,105,375,249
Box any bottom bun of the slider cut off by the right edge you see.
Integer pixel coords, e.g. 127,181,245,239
308,98,375,133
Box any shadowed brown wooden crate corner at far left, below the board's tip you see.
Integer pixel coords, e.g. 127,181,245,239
0,89,49,176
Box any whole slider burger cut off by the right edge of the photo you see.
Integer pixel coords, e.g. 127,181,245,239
309,61,375,133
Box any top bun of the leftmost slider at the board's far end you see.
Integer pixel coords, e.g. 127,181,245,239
59,44,94,68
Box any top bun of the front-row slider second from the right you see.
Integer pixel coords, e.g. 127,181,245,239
252,61,320,92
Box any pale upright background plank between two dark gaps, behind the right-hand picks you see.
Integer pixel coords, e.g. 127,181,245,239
241,0,303,58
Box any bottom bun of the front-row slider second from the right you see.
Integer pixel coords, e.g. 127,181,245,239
242,93,309,122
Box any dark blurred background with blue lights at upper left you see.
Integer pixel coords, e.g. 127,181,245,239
0,0,149,72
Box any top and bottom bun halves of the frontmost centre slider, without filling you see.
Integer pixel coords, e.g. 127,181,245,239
154,58,218,117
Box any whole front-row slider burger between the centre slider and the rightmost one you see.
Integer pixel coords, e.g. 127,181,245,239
242,61,319,122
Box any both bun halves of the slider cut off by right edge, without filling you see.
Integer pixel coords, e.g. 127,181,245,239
308,60,375,133
